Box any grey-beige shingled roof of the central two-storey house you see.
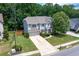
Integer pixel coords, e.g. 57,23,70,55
24,16,51,24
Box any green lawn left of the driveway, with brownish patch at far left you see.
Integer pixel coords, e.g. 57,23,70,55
0,32,37,56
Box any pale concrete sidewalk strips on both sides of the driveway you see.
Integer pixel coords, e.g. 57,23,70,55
14,40,79,56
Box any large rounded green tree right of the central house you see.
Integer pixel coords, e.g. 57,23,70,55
53,11,69,33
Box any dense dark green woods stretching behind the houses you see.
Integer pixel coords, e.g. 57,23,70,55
0,3,79,31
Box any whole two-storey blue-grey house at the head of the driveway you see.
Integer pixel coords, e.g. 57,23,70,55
23,16,52,34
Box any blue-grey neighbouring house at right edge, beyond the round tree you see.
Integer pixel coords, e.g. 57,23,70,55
70,18,79,32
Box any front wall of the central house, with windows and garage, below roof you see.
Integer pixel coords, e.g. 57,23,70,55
28,24,52,33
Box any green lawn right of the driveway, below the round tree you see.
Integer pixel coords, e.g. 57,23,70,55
47,35,79,46
